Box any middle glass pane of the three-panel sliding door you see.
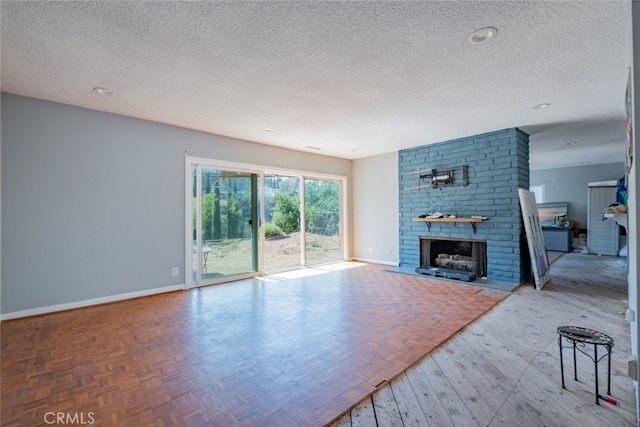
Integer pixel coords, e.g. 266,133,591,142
264,175,302,272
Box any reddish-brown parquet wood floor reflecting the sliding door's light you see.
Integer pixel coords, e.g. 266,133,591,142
0,263,509,427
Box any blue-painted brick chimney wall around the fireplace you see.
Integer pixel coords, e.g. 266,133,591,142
398,128,531,283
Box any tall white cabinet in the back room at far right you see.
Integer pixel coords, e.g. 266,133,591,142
587,181,620,255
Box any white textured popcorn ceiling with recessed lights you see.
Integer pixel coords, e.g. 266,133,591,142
0,0,631,169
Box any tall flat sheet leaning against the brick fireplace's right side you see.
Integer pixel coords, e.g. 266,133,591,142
518,188,551,289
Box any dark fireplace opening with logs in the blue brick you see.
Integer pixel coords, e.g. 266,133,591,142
416,237,487,282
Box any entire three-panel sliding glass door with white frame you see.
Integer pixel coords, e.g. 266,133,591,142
186,157,345,287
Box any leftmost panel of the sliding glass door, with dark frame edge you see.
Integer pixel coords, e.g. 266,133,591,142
190,165,258,286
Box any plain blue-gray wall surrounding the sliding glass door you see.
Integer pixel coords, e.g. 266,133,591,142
1,93,351,314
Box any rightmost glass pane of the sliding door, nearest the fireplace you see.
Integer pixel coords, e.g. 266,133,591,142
304,179,342,264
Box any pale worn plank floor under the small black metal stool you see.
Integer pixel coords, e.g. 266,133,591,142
331,254,637,427
